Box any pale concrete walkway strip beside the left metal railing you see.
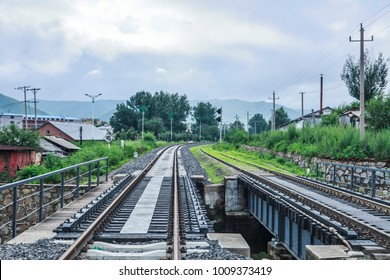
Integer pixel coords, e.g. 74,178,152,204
7,181,112,244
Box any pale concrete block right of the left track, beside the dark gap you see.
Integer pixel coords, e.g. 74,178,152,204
207,233,250,257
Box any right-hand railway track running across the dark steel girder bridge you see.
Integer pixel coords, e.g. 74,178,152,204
202,150,390,248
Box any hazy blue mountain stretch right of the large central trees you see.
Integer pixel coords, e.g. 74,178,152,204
190,99,300,124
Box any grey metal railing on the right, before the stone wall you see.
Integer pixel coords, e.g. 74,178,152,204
316,162,390,199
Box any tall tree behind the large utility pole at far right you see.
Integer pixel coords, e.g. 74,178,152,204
341,50,389,102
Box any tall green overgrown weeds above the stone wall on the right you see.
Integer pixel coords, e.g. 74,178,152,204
225,125,390,160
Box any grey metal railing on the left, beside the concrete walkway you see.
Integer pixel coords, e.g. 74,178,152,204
0,157,108,242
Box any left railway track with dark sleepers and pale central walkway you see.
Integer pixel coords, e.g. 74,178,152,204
56,146,210,260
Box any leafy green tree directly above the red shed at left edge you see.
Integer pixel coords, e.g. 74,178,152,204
0,124,40,149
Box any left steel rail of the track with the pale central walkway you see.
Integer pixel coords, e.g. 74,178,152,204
59,146,171,260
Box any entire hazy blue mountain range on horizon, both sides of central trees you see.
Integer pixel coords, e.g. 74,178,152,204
0,94,300,124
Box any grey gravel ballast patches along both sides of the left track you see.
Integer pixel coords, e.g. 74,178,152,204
0,146,250,260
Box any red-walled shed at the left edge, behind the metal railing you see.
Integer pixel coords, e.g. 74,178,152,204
0,145,37,176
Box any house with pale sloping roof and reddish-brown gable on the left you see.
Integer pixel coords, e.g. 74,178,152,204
38,121,107,141
